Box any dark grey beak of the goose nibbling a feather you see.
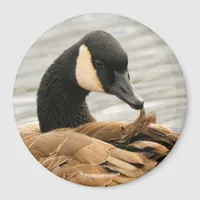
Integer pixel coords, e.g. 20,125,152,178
109,72,144,110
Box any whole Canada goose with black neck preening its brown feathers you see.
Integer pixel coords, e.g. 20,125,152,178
19,31,178,186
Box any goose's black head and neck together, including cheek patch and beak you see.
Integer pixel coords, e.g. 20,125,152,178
37,31,144,132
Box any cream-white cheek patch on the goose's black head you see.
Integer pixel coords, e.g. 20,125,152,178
76,45,105,92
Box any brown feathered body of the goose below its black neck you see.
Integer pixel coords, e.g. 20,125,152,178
19,111,178,186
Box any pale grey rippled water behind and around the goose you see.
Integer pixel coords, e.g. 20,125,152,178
14,14,186,132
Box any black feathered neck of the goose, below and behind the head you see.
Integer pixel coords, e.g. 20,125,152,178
37,46,94,132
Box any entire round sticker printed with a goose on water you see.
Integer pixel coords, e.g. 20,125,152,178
14,14,187,187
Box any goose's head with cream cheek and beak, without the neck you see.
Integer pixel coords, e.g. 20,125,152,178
76,31,143,109
